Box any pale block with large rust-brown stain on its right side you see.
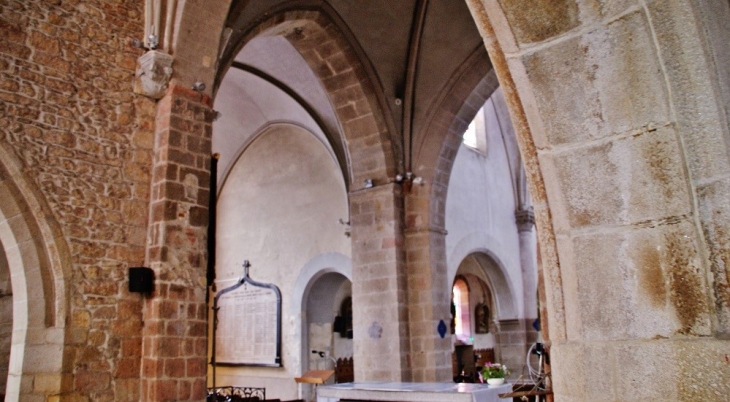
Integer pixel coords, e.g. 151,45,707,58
574,218,710,340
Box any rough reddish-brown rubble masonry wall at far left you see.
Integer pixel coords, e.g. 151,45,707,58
0,0,155,401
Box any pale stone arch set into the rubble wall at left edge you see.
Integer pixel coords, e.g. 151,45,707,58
0,147,70,400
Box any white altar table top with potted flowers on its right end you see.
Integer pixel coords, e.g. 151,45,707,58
317,382,512,402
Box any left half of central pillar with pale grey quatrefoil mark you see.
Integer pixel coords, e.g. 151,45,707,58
350,184,410,381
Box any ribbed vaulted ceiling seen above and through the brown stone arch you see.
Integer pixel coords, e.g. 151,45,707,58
216,0,488,187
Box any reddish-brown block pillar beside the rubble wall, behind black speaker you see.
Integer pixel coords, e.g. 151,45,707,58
141,86,213,401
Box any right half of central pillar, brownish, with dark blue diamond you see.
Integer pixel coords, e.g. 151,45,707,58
405,184,453,382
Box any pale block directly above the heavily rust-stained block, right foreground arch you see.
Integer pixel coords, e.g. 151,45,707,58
542,127,691,228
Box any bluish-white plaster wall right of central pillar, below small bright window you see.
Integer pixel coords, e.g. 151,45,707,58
446,89,534,326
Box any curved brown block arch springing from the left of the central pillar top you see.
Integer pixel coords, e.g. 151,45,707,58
216,1,400,186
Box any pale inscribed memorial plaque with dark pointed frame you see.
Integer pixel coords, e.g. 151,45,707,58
212,265,281,367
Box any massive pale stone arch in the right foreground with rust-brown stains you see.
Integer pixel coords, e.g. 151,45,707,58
469,0,730,401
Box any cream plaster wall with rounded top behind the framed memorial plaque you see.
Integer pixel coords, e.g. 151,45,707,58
210,123,351,399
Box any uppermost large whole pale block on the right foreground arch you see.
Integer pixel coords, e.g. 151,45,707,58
523,11,670,146
